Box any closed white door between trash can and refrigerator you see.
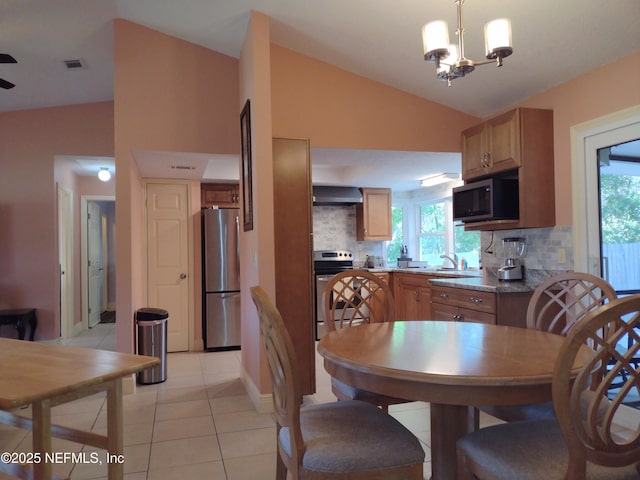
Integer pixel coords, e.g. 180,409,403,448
147,183,191,352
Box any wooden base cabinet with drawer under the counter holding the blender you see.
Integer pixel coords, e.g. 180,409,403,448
431,285,532,328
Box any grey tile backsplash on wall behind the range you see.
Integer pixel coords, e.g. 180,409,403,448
313,205,385,266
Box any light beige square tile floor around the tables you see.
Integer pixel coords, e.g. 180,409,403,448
0,324,500,480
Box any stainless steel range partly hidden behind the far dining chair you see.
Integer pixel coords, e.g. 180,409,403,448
313,250,353,340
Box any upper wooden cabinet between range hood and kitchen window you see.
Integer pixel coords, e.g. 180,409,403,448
356,188,391,242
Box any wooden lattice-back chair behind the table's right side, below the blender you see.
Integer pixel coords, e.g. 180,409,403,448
480,272,617,422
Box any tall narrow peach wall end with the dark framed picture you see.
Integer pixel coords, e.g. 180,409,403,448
237,12,275,393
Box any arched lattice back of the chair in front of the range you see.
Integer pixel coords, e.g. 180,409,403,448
323,269,395,332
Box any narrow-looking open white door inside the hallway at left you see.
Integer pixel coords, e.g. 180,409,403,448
87,202,104,328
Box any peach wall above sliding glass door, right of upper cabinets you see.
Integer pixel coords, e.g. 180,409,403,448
522,52,640,225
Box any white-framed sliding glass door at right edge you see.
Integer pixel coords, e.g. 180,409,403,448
571,106,640,408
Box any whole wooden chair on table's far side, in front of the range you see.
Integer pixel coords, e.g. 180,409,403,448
323,269,408,411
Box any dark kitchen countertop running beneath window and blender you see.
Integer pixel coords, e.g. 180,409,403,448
363,267,541,293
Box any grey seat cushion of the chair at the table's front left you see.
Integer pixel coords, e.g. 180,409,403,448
279,400,425,473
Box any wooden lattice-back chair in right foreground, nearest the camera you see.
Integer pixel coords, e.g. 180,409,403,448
457,295,640,480
